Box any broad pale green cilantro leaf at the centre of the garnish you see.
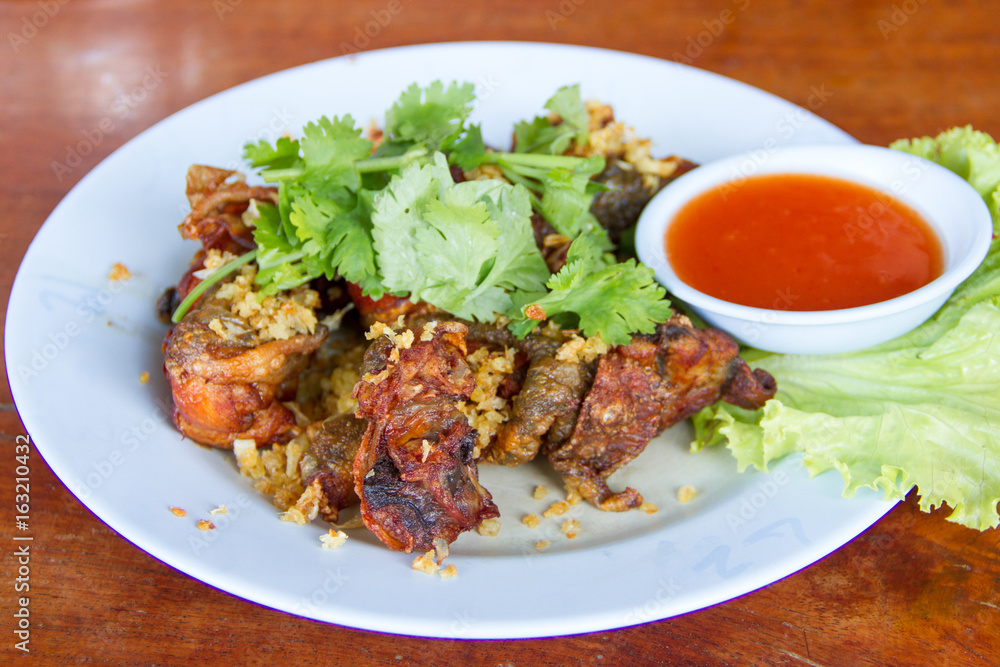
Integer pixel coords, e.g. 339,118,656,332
372,154,549,321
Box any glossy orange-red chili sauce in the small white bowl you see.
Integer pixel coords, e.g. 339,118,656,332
665,174,944,311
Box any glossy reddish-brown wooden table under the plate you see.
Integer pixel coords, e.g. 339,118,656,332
0,0,1000,665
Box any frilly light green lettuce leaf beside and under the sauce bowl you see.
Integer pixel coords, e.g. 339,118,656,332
692,128,1000,530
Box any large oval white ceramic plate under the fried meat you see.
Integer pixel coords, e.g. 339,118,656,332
6,43,892,638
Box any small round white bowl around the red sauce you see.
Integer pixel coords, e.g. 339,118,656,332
635,144,993,354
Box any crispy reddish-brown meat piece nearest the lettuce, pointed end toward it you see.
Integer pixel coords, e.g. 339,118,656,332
549,315,776,511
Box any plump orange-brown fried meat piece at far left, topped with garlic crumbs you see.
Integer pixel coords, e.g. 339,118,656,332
163,288,327,447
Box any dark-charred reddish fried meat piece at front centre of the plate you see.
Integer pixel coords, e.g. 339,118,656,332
354,322,499,553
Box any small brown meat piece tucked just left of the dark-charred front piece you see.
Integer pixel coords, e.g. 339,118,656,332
299,415,368,523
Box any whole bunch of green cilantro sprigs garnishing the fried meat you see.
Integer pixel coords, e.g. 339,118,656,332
174,81,670,344
